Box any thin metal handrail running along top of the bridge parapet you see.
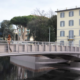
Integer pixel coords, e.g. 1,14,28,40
0,40,80,47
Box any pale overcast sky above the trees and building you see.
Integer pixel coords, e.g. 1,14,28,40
0,0,80,22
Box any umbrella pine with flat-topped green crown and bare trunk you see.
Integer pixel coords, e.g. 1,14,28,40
10,15,36,40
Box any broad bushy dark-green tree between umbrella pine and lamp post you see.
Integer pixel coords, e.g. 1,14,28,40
28,16,48,41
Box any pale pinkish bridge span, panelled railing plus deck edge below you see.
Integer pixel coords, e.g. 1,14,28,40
0,41,80,56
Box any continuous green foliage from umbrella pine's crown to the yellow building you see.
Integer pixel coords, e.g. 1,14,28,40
10,15,57,41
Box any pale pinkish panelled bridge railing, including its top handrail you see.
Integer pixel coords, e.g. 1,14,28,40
0,41,80,53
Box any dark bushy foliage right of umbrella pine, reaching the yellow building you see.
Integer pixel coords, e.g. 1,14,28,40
28,16,57,41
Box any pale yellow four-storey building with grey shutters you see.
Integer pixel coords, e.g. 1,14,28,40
56,8,80,45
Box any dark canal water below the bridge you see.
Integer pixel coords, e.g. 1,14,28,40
0,57,80,80
